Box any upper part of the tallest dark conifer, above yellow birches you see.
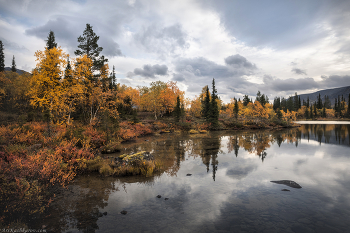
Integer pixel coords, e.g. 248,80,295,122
74,23,108,71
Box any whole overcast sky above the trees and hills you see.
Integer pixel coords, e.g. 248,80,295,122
0,0,350,102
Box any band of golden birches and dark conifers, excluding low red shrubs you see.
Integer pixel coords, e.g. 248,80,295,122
0,24,350,128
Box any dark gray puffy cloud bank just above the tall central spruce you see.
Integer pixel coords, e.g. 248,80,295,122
173,54,259,101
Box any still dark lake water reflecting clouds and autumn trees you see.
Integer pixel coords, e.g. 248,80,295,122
37,124,350,232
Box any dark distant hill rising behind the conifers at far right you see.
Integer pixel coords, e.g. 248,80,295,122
298,86,350,105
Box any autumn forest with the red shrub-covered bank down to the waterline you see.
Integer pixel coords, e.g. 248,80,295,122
0,24,350,225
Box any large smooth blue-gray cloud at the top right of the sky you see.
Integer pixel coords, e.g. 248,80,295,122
201,0,340,48
